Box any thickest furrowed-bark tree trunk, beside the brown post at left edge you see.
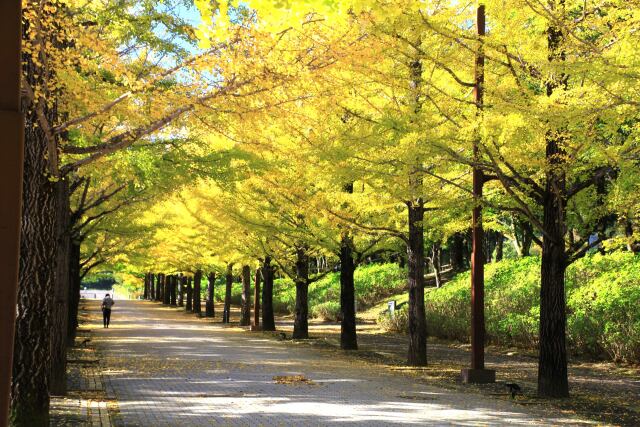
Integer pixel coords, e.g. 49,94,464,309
10,87,57,427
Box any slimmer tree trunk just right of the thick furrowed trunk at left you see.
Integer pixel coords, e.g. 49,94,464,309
50,179,71,396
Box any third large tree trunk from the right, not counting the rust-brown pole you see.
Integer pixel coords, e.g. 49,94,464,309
340,234,358,350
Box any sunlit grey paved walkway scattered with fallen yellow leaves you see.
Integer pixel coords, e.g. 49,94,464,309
92,301,592,426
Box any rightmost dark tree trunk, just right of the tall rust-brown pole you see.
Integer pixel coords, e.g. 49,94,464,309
538,136,569,397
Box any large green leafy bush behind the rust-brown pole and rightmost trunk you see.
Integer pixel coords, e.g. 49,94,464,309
426,252,640,363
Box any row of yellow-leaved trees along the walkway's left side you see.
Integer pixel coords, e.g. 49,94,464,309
10,0,316,426
